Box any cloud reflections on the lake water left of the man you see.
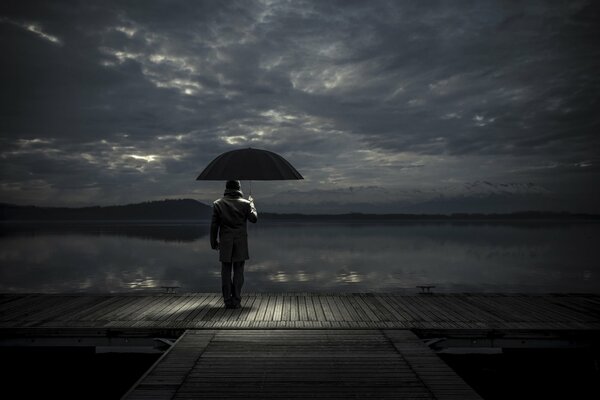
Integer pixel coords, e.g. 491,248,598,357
0,233,220,292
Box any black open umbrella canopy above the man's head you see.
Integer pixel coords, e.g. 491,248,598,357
196,148,304,181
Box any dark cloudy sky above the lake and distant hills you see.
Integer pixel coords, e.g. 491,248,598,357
0,0,600,212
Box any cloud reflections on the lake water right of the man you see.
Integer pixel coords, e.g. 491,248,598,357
247,222,597,291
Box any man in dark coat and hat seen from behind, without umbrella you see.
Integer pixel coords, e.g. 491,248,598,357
210,181,258,308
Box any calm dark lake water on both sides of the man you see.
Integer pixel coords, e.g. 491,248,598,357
0,221,600,293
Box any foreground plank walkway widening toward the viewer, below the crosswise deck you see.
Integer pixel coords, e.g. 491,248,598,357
123,329,480,400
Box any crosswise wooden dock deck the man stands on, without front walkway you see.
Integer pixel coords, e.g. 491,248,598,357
0,293,600,331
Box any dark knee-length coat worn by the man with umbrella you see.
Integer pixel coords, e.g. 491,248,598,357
210,189,258,262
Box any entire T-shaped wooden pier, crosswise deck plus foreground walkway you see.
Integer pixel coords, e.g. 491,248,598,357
0,293,600,399
